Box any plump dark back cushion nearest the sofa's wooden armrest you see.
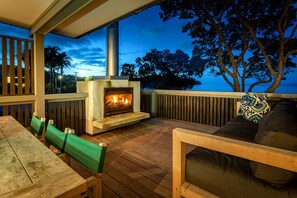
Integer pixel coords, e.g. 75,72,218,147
250,99,297,187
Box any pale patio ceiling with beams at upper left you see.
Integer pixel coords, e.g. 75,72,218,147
0,0,160,38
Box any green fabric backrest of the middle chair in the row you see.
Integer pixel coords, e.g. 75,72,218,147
45,120,68,152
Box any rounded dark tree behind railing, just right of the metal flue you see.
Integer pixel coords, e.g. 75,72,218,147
135,49,201,89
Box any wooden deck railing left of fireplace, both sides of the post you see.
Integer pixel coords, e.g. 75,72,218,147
0,93,87,134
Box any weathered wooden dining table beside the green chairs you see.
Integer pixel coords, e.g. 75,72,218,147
0,116,87,198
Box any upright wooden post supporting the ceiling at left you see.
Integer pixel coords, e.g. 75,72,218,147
33,33,45,117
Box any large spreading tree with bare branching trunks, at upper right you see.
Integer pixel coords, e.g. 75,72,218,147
160,0,297,92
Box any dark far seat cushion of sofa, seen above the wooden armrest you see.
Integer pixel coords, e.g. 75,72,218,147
213,115,258,142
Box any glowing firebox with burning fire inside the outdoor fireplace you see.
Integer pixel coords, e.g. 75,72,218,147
104,87,133,117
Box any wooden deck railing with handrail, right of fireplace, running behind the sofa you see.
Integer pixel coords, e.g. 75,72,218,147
141,90,297,126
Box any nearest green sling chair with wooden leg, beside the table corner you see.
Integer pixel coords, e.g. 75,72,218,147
65,133,106,197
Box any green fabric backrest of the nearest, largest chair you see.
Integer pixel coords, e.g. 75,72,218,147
65,133,106,173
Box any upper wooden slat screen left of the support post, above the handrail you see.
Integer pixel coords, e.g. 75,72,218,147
0,35,34,96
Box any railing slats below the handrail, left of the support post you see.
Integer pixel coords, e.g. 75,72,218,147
0,103,34,127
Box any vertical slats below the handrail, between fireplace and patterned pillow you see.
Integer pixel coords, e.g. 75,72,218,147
157,94,238,126
